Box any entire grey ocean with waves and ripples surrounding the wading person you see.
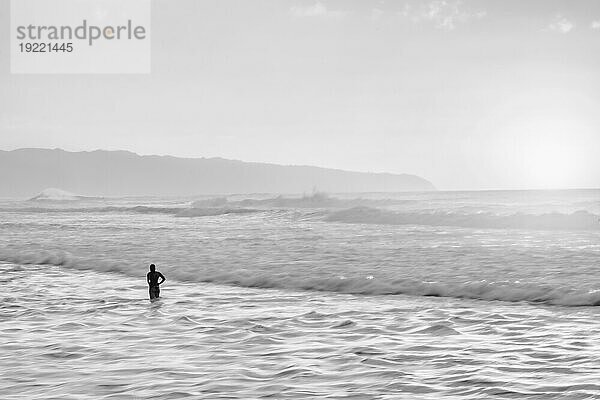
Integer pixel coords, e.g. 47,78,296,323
0,190,600,399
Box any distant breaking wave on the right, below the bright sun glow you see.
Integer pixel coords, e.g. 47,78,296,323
326,207,600,230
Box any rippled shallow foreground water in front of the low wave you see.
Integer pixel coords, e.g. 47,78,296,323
0,264,600,399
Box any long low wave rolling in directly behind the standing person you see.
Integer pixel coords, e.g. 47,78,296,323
0,250,600,306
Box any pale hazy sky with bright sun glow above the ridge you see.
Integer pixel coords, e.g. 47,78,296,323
0,0,600,189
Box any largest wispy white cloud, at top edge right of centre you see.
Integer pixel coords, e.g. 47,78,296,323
400,0,486,31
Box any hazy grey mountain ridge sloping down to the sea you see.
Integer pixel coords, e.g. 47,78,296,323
0,148,436,197
